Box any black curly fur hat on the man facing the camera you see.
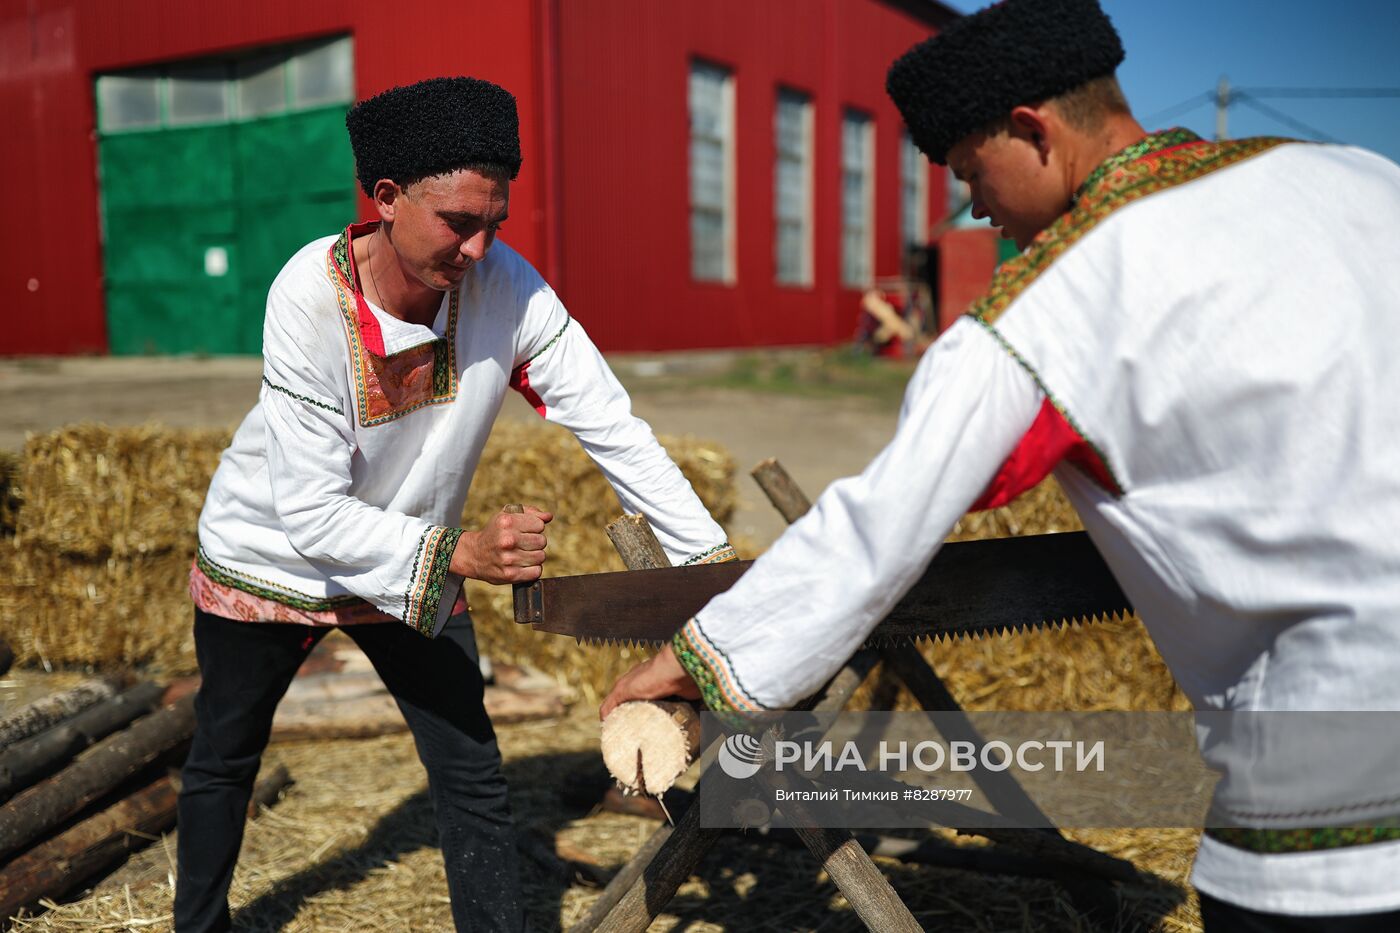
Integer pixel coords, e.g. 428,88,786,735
346,77,521,196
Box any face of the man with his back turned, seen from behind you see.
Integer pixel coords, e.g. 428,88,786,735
948,127,1072,249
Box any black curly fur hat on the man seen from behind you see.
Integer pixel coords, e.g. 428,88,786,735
885,0,1123,164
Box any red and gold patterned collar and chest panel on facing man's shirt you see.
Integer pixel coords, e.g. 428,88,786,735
326,226,461,427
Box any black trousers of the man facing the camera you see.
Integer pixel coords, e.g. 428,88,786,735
175,609,524,933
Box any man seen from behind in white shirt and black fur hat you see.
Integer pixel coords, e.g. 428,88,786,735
602,0,1400,930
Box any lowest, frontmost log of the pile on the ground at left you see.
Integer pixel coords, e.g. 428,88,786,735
0,776,175,918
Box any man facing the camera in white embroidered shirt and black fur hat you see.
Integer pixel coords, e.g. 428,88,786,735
175,78,734,932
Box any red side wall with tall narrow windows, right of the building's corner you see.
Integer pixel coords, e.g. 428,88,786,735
546,0,945,350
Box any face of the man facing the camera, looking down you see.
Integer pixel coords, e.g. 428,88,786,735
379,170,511,291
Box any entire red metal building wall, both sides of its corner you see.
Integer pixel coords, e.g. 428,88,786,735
0,0,946,354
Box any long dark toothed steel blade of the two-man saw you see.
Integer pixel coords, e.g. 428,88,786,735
515,531,1133,644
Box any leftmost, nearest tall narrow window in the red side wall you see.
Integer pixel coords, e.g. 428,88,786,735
690,62,734,282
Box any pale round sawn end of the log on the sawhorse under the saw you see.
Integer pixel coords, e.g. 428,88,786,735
602,700,700,796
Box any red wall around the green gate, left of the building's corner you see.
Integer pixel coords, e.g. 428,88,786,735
0,0,550,354
